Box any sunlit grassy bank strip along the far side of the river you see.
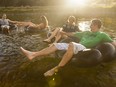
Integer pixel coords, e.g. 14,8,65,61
0,6,116,17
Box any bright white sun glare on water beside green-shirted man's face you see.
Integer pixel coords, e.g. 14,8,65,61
79,21,90,31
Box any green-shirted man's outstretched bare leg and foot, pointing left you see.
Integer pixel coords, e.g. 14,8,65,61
20,45,57,60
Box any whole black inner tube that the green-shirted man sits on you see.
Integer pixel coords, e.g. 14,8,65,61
56,43,116,66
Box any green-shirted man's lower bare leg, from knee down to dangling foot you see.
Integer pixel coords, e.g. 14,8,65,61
44,43,74,76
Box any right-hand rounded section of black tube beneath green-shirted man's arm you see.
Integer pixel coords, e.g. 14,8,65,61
96,43,116,62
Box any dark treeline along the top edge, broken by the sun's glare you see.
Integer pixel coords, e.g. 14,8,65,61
0,0,116,7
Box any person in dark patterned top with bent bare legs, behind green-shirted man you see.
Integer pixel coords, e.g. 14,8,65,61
44,16,80,43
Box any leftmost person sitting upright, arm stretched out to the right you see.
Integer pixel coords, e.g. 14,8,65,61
0,14,17,34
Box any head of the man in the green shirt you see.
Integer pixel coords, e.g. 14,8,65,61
90,19,102,32
